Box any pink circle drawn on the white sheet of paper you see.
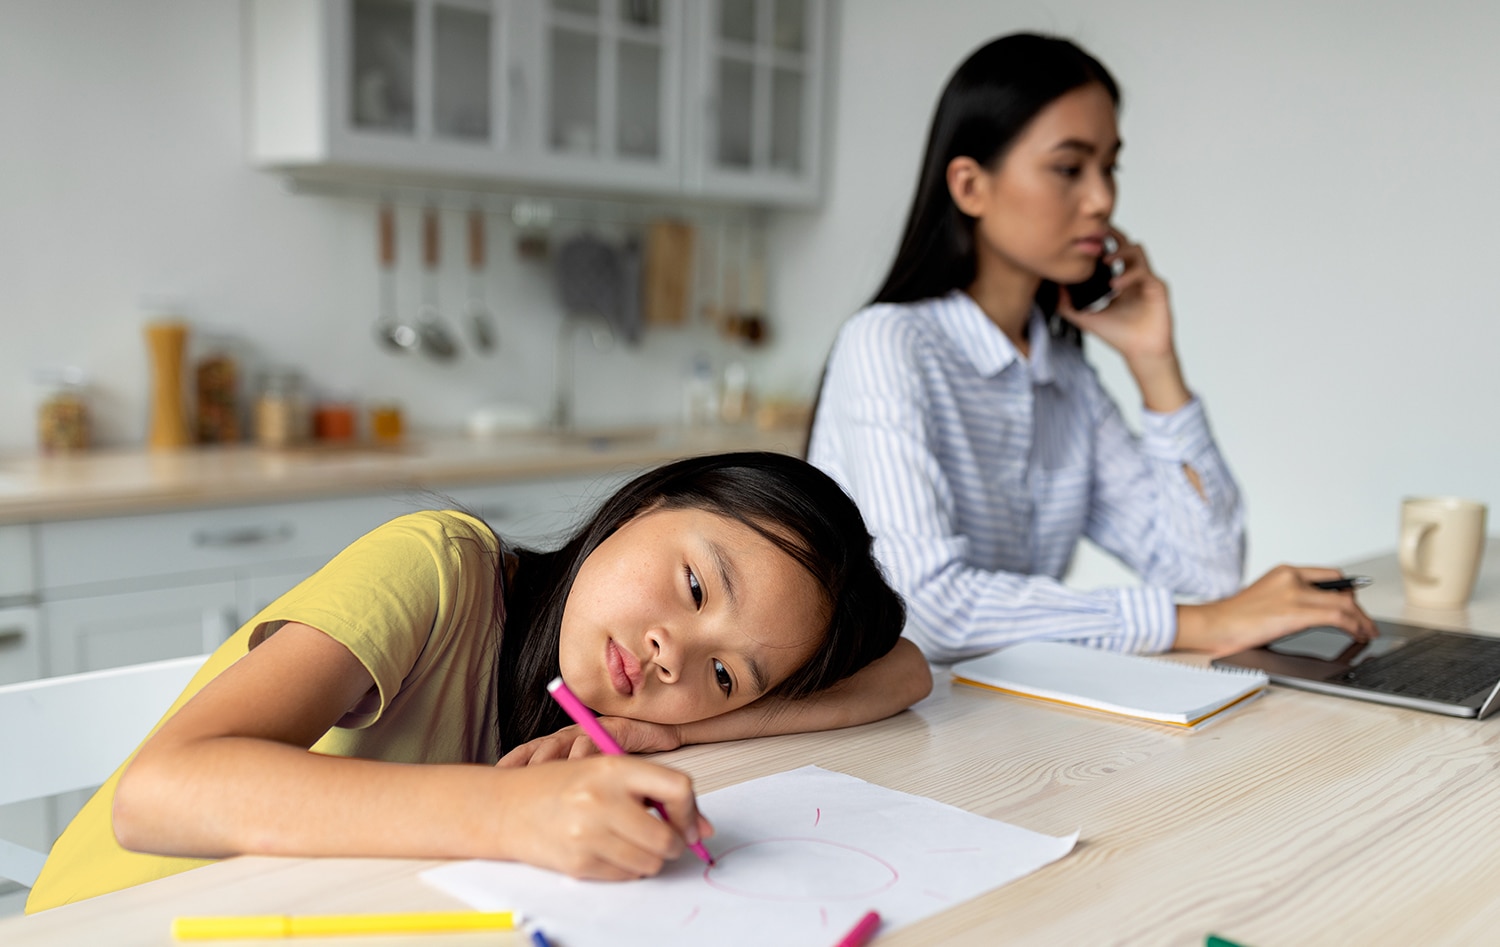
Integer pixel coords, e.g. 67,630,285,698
704,837,900,900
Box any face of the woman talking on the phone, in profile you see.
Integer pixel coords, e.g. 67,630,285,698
948,84,1121,284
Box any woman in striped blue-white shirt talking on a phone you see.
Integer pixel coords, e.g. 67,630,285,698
809,35,1374,660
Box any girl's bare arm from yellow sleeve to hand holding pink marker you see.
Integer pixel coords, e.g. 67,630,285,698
114,623,713,878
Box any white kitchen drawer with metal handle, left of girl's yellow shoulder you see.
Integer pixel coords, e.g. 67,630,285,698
36,497,410,597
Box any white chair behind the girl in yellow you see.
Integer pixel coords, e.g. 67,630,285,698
0,654,209,887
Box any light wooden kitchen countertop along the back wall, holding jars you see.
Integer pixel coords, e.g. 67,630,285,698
0,426,806,525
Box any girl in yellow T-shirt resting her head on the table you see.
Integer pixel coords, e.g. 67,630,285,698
27,453,932,911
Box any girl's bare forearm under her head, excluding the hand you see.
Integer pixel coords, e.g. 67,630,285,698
680,638,933,743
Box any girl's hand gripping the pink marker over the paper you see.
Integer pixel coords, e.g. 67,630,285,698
498,756,714,881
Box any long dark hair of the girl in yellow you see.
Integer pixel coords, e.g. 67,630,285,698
498,452,906,749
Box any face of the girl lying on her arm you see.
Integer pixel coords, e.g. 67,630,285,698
558,510,828,723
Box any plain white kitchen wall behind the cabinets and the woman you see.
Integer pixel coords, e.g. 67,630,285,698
0,0,1500,581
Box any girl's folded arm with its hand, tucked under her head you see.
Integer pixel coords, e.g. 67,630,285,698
500,638,933,767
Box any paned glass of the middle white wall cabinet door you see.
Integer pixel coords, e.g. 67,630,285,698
542,0,677,165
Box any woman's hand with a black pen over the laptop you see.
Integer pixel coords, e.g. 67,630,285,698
1176,566,1379,657
